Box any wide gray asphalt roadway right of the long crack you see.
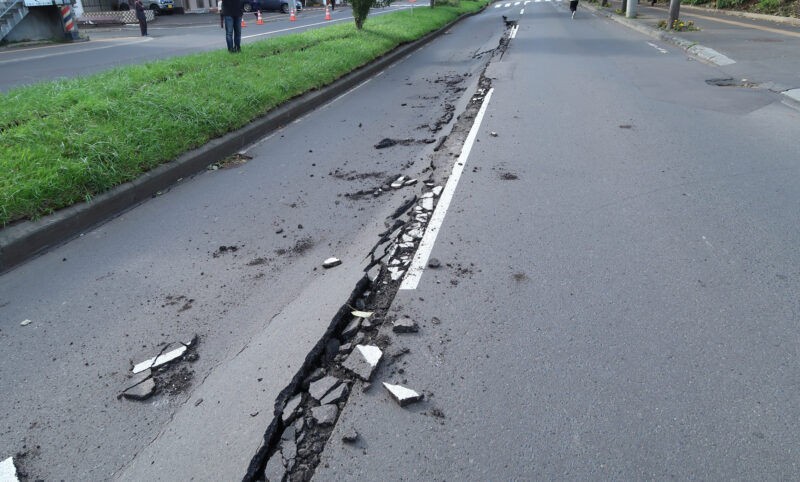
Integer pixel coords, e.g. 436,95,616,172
315,3,800,480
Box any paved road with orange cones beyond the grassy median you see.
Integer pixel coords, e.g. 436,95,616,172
0,2,422,92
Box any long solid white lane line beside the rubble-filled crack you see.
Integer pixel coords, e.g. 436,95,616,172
400,88,494,290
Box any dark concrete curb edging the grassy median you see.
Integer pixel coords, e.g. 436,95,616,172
0,7,485,273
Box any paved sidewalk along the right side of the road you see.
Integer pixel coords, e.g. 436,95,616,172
581,0,800,102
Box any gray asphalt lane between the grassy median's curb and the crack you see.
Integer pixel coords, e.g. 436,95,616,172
0,5,503,480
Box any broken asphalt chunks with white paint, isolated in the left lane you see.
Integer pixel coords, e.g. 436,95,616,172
117,335,198,400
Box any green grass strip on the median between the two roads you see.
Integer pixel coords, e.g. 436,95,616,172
0,0,488,225
